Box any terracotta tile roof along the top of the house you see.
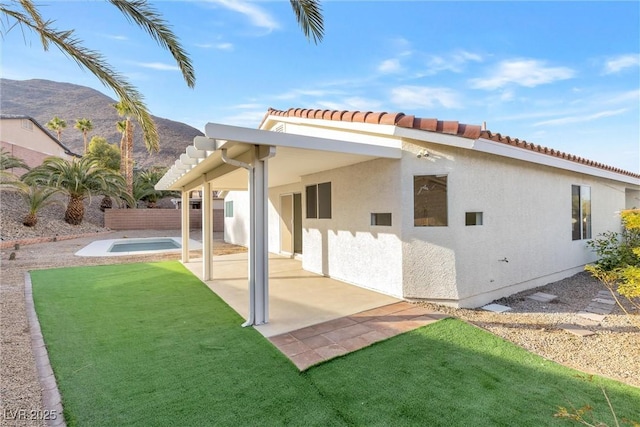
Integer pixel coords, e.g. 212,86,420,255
260,108,640,178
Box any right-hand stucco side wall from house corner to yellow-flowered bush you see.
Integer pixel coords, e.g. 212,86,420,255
402,140,626,307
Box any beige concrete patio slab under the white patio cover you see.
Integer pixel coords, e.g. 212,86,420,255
185,253,400,337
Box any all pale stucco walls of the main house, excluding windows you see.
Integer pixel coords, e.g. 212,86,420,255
220,134,640,307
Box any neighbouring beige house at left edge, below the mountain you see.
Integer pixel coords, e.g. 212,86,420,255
0,114,79,174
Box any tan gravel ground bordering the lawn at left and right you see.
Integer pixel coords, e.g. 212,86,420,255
0,191,640,426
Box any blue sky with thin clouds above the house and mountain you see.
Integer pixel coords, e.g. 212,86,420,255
2,0,640,172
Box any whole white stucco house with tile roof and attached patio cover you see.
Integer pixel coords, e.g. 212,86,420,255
158,109,640,324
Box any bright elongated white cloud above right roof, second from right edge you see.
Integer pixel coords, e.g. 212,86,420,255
470,59,575,90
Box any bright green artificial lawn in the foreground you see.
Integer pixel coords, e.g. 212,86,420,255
31,262,640,426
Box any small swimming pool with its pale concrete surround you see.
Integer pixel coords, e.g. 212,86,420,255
75,237,202,256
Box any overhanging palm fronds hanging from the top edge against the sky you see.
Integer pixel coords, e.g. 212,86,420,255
0,0,324,150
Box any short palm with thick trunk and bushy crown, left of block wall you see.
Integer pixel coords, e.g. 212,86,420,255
23,157,133,225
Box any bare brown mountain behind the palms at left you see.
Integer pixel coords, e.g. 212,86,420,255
0,79,203,169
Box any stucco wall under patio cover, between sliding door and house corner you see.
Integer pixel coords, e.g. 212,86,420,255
302,159,402,297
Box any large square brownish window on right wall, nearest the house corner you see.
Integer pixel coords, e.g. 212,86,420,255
413,175,448,227
